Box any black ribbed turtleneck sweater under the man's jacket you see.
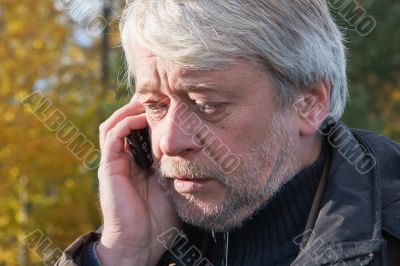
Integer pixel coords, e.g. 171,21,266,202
164,152,325,266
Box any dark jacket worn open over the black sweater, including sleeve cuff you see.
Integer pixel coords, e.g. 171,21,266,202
56,121,400,266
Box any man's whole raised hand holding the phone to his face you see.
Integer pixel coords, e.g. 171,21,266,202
96,102,179,266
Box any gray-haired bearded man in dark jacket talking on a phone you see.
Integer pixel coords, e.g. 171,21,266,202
58,0,400,265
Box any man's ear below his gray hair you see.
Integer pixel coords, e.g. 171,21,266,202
295,80,331,136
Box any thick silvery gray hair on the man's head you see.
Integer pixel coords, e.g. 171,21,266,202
120,0,348,119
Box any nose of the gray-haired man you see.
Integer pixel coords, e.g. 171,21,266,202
160,107,201,157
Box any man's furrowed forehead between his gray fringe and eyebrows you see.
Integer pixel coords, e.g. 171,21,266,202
134,49,268,97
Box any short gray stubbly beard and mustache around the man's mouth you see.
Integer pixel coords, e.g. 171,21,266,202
154,115,300,232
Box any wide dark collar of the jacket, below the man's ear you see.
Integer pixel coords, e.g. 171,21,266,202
292,122,384,265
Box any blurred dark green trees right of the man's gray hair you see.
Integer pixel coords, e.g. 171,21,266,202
331,0,400,141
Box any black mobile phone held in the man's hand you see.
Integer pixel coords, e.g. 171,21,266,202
126,128,153,169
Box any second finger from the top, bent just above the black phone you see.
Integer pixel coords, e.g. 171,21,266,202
103,114,148,161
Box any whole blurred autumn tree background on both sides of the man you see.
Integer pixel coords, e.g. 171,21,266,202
0,0,400,266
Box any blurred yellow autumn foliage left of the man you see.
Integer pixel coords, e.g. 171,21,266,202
0,0,124,265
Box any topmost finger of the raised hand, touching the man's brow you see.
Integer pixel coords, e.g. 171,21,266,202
99,102,144,149
